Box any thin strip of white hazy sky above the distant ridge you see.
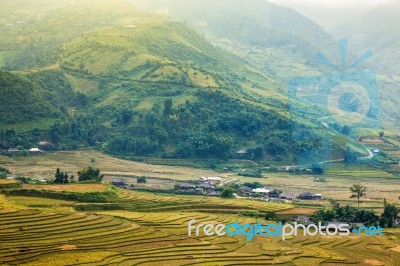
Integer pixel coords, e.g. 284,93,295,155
268,0,395,9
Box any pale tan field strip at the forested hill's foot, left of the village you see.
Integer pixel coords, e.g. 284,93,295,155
0,150,218,180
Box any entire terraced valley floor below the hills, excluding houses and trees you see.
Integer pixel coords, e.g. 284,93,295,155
0,151,400,266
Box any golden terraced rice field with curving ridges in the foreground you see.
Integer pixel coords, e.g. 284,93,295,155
0,210,400,265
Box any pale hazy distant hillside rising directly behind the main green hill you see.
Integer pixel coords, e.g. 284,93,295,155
133,0,336,80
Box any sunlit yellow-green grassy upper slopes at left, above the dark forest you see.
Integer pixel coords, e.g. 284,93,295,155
0,0,278,130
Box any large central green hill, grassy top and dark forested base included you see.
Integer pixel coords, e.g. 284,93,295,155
0,0,360,162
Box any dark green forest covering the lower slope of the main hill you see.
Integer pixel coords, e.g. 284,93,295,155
106,91,332,159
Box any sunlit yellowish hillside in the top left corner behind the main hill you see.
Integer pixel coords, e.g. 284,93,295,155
0,0,146,70
